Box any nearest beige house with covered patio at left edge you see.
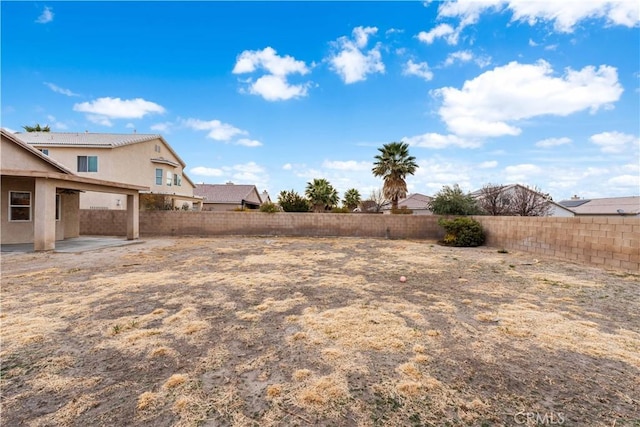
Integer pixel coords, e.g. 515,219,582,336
0,129,149,251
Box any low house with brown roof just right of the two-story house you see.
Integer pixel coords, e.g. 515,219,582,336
193,182,263,211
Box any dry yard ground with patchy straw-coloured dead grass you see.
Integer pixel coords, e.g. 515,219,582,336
0,237,640,427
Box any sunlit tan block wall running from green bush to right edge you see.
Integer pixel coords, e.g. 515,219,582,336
475,216,640,273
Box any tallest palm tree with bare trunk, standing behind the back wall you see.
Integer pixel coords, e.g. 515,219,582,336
371,142,418,210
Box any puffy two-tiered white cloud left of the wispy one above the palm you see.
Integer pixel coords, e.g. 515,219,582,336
232,47,310,101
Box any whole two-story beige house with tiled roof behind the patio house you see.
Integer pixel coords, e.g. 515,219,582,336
15,132,201,210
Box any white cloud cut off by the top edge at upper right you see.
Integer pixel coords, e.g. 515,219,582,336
438,0,640,33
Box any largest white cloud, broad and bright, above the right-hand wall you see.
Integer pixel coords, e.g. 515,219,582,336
434,60,623,137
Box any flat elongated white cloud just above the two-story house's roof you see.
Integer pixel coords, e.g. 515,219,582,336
73,97,165,126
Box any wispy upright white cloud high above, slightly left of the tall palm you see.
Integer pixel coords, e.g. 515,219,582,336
329,27,385,84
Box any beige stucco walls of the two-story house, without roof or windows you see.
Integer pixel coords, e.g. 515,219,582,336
33,139,193,210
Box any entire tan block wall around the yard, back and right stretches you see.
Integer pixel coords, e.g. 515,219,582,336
80,210,640,272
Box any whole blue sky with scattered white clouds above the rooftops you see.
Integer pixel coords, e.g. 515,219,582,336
0,0,640,200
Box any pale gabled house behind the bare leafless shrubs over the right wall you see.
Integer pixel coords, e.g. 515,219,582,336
470,184,574,217
